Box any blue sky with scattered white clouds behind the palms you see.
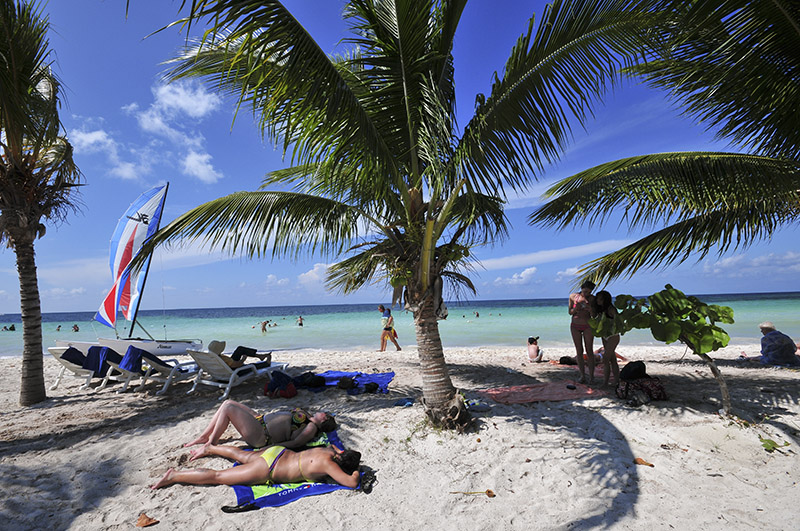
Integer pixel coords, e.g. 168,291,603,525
0,0,800,313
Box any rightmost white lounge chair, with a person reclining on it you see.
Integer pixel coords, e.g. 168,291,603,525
186,341,289,400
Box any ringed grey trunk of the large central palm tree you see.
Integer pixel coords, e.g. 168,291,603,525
414,297,472,431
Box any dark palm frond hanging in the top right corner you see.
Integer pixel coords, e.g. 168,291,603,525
632,0,800,159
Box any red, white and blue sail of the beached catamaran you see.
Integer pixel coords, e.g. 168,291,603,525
94,185,167,328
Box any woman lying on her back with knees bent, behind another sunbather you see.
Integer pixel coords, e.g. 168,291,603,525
183,400,336,455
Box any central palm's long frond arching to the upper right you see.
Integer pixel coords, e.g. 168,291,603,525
455,0,655,194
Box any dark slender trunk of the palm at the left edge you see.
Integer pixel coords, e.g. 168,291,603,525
14,238,47,406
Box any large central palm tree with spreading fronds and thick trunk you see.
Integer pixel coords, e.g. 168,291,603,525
141,0,650,427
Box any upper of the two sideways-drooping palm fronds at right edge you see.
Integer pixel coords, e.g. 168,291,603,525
529,152,800,229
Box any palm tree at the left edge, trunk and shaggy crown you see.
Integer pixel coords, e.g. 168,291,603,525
0,0,80,406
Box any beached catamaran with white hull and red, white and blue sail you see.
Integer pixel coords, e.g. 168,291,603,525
56,184,202,356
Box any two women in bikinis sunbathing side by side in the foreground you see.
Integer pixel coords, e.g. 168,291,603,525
151,400,361,489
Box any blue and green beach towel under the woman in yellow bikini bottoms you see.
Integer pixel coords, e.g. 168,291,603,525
223,431,354,512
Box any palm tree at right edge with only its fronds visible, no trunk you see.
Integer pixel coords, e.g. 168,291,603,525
530,0,800,283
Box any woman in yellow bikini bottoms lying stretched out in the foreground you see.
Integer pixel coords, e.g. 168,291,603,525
150,444,361,489
